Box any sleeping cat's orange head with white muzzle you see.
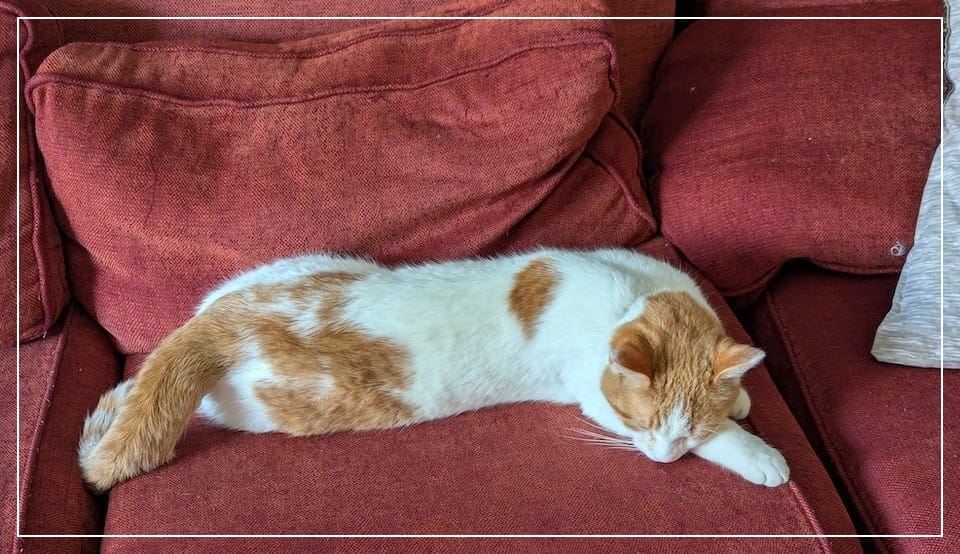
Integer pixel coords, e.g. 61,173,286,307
600,292,764,462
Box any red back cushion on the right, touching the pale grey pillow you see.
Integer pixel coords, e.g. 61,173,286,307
642,20,941,297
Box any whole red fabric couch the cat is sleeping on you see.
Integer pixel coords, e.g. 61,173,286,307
0,0,960,552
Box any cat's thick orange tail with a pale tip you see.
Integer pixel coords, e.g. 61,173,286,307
78,313,230,493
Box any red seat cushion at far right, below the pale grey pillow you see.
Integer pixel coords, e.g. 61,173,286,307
750,266,960,552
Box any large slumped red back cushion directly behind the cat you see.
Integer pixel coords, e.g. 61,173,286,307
30,2,654,353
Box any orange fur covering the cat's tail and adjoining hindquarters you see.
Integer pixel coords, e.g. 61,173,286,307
80,273,413,491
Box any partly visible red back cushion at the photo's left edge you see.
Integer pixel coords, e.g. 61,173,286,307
0,2,68,346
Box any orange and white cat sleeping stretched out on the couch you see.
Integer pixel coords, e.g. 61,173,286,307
79,249,789,491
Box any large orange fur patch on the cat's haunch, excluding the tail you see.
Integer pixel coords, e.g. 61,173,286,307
246,273,414,435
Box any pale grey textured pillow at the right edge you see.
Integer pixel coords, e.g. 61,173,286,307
872,2,960,369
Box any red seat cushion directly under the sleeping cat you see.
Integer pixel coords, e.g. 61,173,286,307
104,239,857,551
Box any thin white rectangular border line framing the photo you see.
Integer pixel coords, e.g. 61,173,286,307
15,12,944,539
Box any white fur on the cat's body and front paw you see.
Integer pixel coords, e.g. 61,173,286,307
191,249,786,484
